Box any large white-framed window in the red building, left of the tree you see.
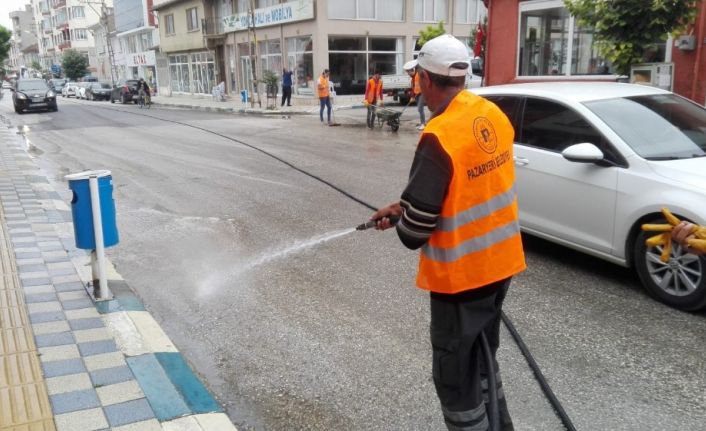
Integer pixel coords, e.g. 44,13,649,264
518,0,612,76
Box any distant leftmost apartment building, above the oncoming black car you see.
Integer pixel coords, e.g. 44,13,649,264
9,5,39,73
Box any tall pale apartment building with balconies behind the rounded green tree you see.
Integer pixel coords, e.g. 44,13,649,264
31,0,113,73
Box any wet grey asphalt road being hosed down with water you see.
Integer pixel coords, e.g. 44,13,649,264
0,97,706,431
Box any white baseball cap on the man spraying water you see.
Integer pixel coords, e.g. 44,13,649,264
405,34,470,76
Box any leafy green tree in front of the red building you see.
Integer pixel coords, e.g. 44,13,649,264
564,0,697,75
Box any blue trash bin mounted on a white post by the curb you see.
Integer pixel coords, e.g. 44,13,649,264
65,170,118,250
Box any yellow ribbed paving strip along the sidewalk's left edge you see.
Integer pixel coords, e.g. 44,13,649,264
0,212,56,431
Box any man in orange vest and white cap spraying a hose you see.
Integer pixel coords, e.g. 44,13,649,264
372,34,525,430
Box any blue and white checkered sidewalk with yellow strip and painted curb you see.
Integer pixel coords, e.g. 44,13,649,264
0,119,236,431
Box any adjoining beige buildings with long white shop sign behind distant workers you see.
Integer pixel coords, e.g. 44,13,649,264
154,0,486,96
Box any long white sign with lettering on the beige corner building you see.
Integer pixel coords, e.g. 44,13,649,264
223,0,314,32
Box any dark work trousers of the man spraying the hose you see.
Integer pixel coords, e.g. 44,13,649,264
430,278,513,431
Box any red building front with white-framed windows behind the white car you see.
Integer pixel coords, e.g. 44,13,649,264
485,0,706,105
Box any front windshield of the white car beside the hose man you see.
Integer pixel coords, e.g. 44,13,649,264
585,94,706,160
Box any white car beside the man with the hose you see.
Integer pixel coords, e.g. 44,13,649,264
473,82,706,310
